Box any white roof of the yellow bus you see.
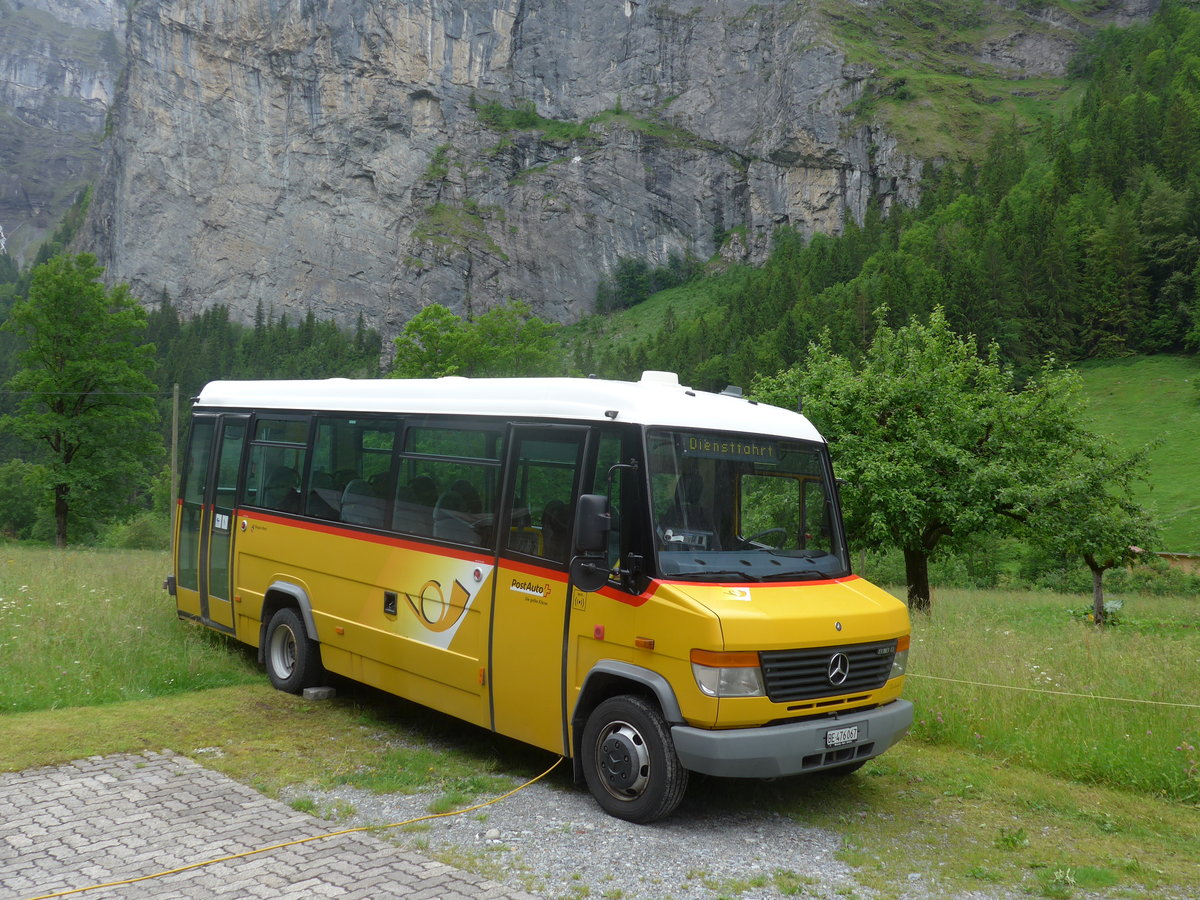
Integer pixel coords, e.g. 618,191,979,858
197,372,823,443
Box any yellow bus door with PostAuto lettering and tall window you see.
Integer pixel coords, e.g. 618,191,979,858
488,426,588,752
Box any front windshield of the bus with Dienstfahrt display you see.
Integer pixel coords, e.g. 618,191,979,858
648,431,850,581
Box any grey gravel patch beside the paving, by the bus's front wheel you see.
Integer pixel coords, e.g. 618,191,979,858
284,778,864,900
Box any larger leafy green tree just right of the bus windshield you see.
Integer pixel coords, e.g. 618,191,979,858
754,308,1108,610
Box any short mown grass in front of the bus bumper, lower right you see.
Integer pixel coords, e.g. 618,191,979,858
689,740,1200,898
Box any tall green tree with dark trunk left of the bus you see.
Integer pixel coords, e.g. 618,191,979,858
0,253,162,547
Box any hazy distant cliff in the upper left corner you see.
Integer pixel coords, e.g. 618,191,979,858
0,0,125,262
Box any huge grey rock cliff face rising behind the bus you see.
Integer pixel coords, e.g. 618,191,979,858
77,0,1152,335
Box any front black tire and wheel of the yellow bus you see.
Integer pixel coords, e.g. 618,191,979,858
581,695,688,824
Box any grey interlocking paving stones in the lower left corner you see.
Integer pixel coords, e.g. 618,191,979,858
0,752,536,900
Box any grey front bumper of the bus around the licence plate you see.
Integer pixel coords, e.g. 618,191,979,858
671,700,912,778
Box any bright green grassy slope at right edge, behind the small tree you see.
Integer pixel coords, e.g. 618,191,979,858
1079,355,1200,553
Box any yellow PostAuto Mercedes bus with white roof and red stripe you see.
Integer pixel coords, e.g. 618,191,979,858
167,372,912,822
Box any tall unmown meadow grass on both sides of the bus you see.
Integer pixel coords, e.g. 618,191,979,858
0,545,1200,803
